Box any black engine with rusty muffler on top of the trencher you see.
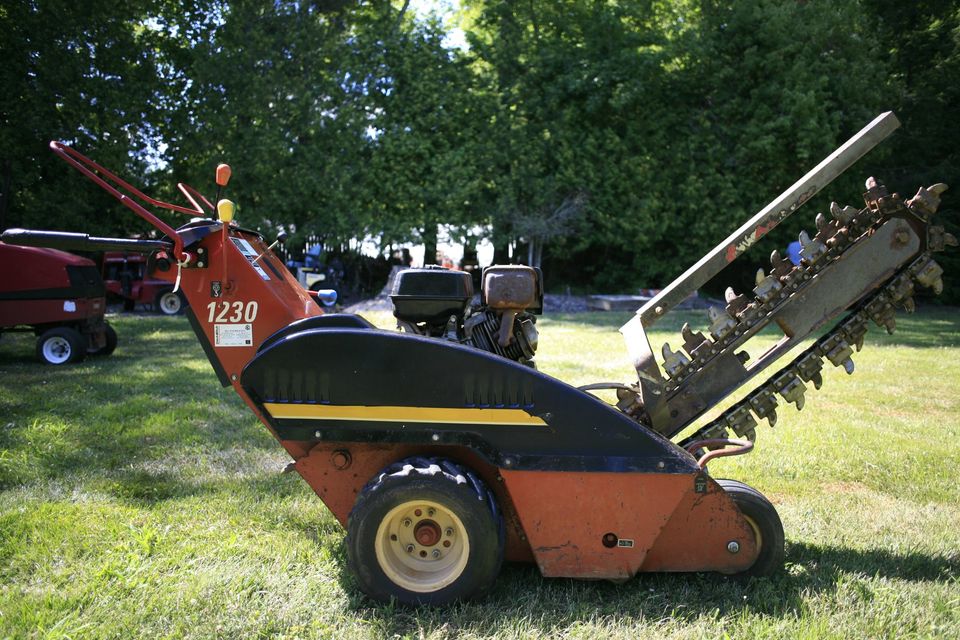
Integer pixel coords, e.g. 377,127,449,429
390,265,543,366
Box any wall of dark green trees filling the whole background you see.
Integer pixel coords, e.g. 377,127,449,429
0,0,960,300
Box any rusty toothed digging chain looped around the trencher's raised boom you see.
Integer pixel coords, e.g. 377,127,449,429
663,178,957,446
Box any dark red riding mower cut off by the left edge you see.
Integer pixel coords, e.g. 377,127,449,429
0,242,117,365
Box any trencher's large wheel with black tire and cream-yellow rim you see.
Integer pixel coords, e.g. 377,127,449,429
346,457,504,605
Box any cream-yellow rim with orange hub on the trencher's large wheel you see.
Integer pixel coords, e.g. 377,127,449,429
374,500,470,593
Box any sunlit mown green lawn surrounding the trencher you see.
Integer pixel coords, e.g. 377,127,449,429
0,308,960,639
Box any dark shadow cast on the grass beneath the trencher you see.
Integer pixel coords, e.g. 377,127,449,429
340,544,960,637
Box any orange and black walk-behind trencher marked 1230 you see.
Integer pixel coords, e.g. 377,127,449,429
3,113,957,604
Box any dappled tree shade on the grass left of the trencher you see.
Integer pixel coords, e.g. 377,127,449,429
0,321,278,490
